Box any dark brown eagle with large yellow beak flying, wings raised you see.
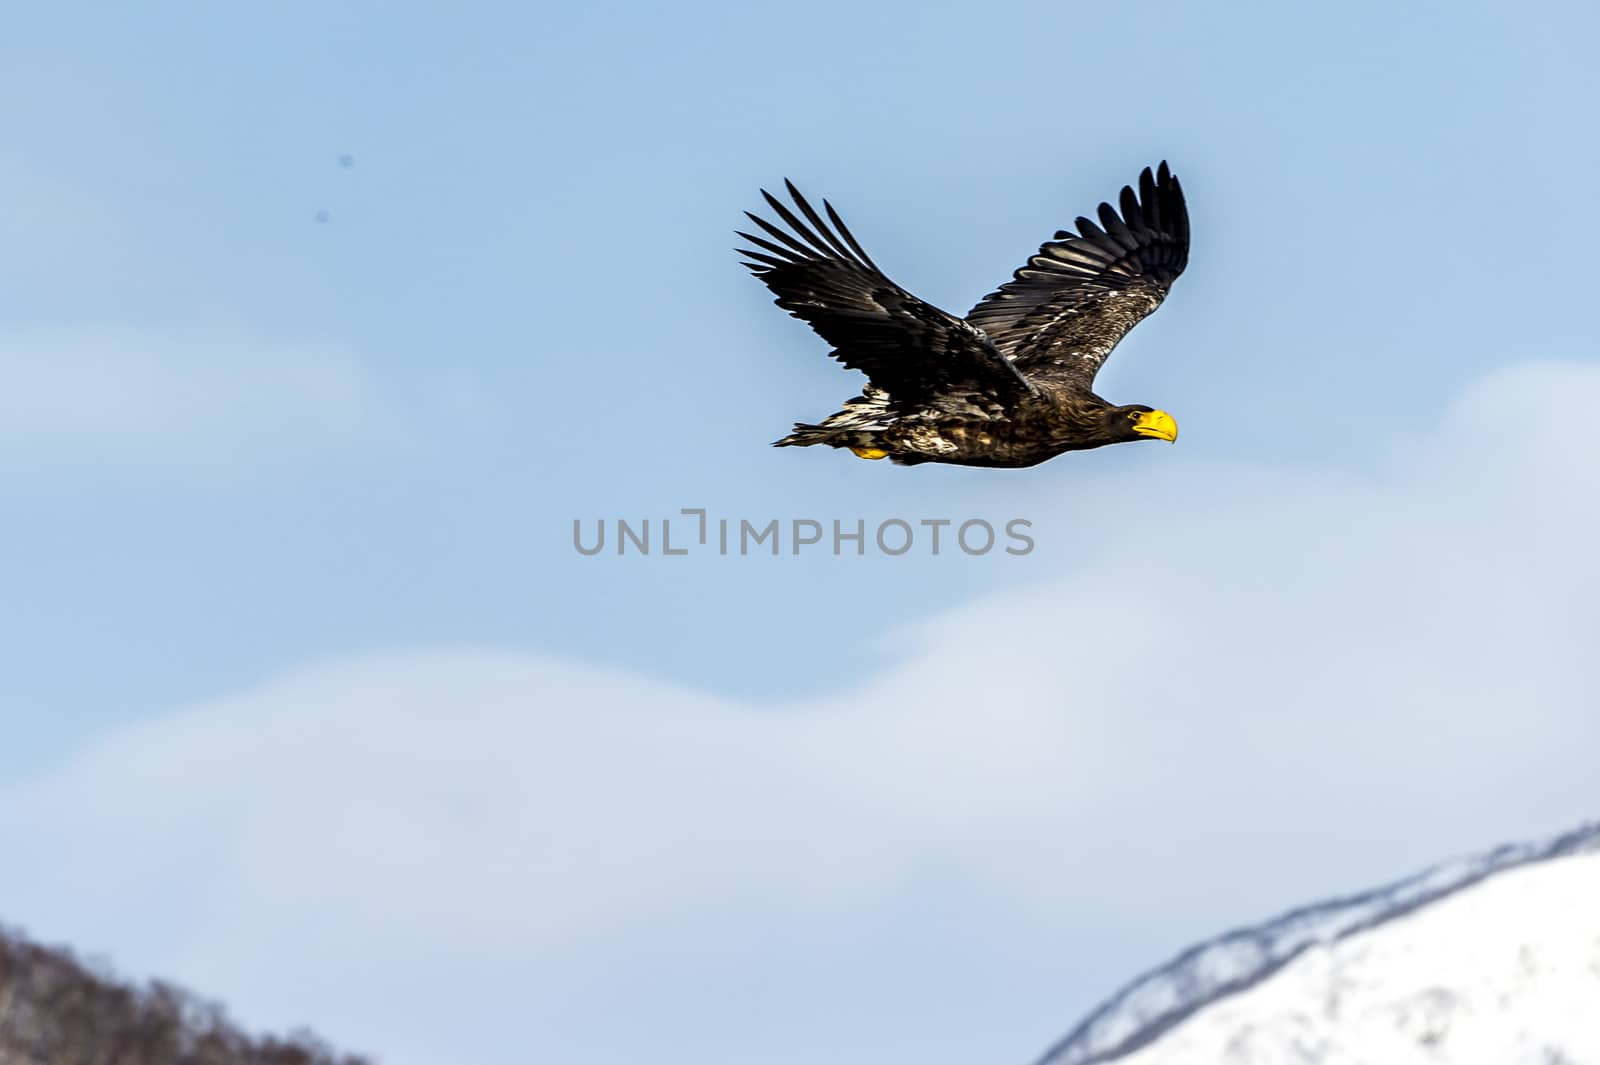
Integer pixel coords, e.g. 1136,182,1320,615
739,162,1189,467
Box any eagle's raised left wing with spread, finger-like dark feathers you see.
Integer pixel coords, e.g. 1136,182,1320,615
739,181,1034,409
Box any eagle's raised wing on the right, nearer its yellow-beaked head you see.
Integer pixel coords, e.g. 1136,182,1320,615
966,162,1189,389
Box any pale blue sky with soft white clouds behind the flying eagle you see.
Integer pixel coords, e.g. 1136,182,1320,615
0,0,1600,1065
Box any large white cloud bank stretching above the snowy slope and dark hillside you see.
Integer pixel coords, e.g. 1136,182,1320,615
0,358,1600,1065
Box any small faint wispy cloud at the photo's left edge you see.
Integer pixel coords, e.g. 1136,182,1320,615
0,328,371,462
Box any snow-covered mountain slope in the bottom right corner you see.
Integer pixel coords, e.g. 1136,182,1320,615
1038,825,1600,1065
